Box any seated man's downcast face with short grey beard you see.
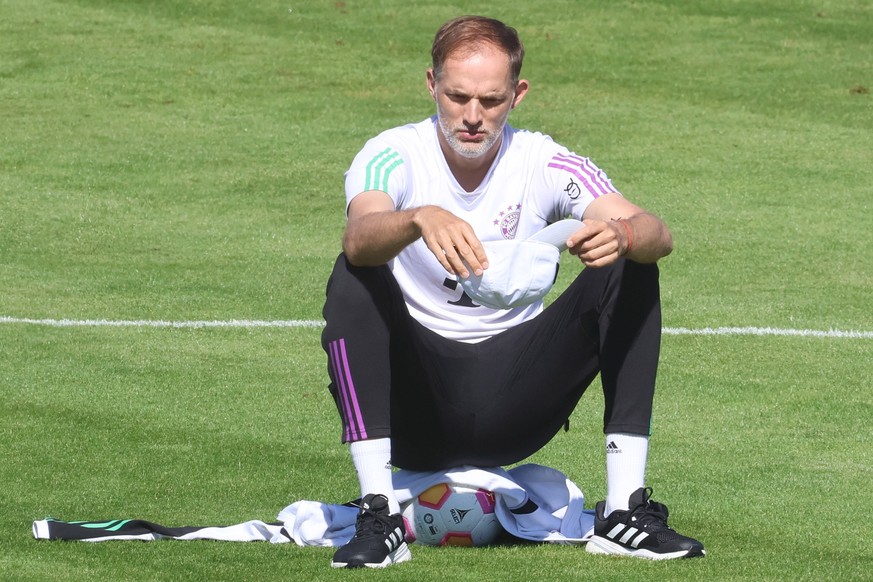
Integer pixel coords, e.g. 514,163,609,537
427,45,528,159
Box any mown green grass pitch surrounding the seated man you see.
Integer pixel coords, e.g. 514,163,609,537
0,0,873,581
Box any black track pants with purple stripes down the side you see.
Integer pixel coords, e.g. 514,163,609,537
322,255,661,471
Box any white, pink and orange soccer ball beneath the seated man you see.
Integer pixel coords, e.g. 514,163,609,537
401,483,503,546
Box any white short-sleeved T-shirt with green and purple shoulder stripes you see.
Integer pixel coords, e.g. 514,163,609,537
345,116,616,342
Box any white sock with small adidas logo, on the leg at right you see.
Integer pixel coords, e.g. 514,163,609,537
604,433,649,515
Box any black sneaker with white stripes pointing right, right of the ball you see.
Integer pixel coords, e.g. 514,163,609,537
586,487,706,560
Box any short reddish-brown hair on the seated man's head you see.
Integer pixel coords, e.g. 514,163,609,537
431,16,524,82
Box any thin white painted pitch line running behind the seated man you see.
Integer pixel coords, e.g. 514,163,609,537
0,316,873,339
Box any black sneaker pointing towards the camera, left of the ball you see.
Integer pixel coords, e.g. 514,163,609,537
331,494,412,568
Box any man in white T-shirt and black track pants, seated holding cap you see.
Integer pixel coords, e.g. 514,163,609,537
322,16,705,568
